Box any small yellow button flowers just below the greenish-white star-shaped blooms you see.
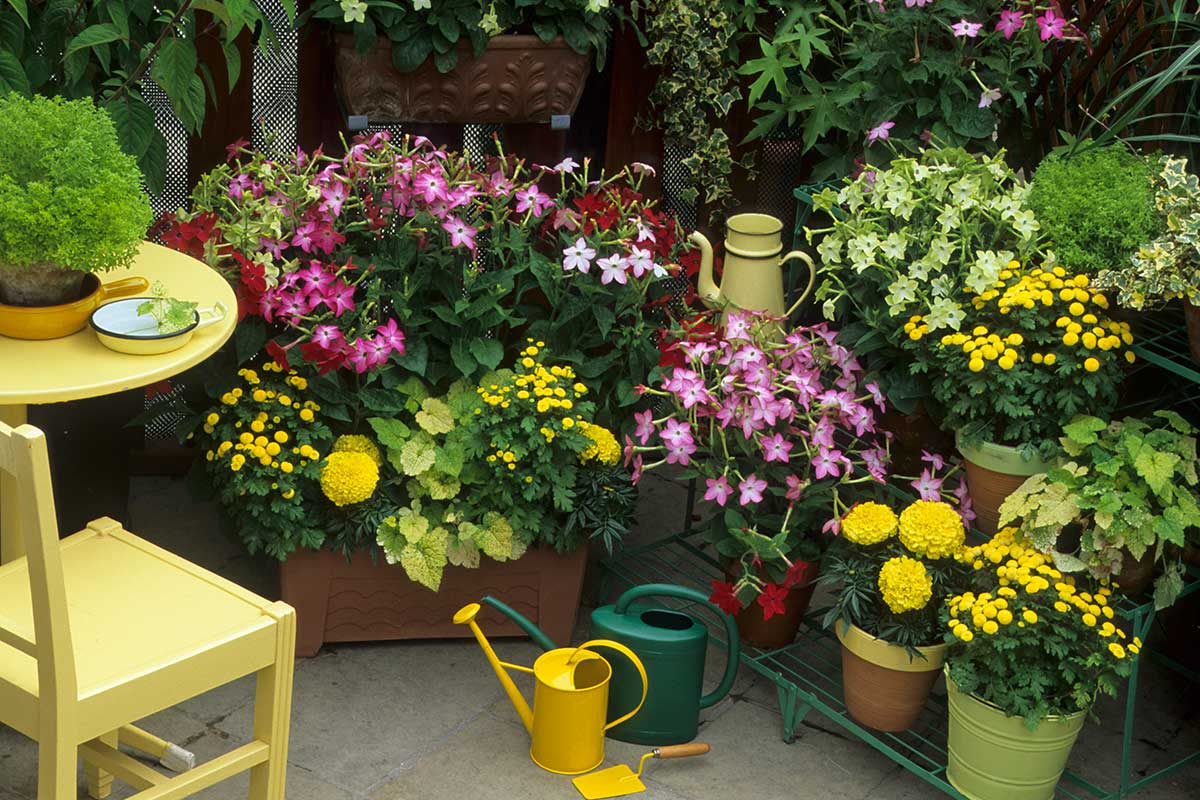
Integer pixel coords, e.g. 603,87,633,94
931,261,1136,372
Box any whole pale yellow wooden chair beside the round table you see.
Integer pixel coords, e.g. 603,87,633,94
0,423,295,800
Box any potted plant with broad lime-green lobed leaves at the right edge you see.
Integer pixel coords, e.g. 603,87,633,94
1000,411,1200,609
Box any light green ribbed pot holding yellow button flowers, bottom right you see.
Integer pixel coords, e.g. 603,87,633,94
946,672,1087,800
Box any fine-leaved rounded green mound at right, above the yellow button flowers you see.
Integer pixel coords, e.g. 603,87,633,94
1028,145,1162,275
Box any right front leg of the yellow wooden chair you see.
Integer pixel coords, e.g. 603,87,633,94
250,603,296,800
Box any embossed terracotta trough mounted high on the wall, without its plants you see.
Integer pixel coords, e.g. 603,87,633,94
335,34,592,125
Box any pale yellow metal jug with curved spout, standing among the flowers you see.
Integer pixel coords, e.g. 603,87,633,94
691,213,816,317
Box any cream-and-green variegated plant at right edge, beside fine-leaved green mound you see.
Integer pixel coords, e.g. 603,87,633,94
1096,156,1200,362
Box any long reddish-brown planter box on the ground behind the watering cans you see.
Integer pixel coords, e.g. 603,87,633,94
280,547,588,657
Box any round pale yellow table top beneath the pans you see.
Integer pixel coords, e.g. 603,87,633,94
0,242,238,405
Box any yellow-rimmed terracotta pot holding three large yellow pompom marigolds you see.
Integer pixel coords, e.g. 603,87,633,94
834,620,946,733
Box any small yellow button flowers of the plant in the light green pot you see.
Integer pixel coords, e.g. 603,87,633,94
948,528,1141,660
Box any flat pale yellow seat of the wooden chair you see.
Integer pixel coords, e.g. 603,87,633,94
0,521,275,743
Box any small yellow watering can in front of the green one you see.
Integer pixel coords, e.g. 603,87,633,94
454,603,649,775
